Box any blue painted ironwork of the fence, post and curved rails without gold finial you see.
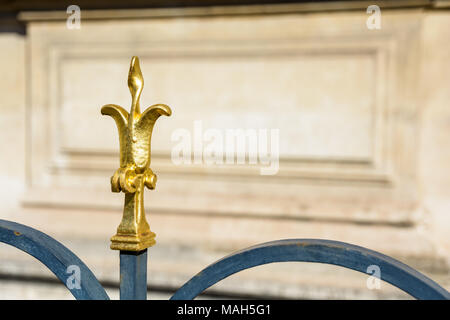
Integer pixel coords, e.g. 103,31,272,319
0,220,450,300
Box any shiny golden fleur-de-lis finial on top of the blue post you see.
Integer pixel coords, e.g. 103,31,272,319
101,57,172,251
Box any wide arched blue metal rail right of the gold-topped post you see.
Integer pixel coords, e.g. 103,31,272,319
171,239,450,300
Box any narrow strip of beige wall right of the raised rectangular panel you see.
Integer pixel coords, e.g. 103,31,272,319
418,13,450,261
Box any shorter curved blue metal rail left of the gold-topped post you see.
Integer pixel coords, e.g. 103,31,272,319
0,219,109,300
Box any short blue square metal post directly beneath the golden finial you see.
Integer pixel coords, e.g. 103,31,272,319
120,249,147,300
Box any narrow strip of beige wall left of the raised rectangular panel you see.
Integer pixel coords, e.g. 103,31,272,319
0,33,25,218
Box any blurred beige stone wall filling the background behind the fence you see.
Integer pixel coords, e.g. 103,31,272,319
0,3,450,298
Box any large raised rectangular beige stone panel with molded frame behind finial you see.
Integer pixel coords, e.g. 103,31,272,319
24,11,426,224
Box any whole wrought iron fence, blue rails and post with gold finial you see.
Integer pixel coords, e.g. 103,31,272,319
0,57,450,300
